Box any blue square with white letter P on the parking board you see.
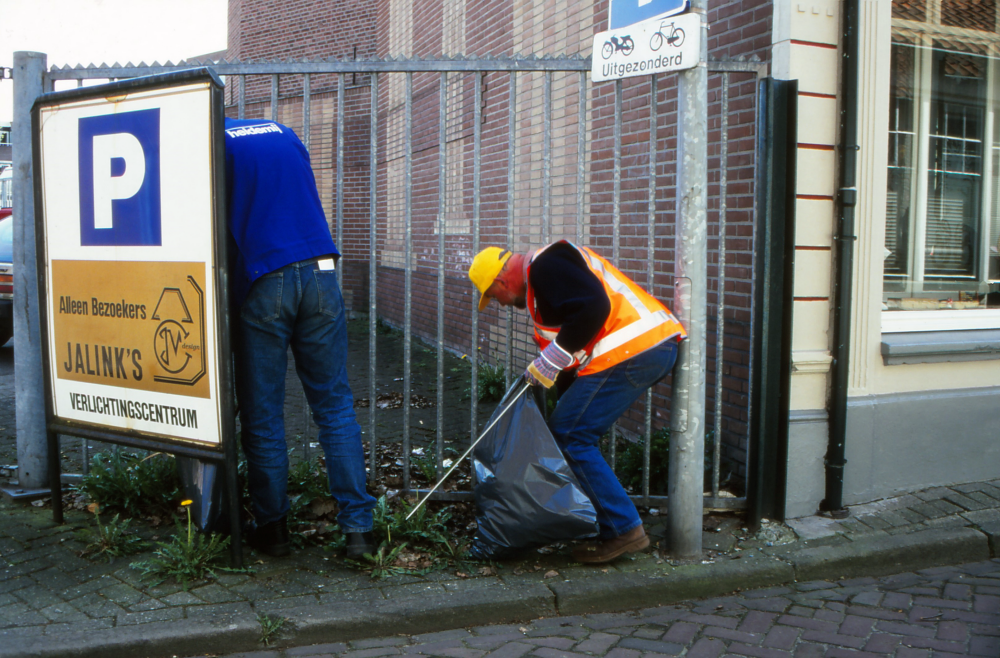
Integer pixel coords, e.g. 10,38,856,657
79,108,161,247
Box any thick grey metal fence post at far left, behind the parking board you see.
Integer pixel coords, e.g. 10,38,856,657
11,51,49,490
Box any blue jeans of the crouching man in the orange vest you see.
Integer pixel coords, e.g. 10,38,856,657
549,339,677,539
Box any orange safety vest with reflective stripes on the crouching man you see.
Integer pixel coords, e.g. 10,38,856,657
525,240,687,375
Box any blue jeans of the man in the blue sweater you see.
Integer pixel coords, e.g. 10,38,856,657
235,261,375,532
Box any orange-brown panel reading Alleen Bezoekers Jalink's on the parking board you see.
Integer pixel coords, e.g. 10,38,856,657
51,260,209,398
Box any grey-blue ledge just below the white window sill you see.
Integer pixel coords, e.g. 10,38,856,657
882,329,1000,366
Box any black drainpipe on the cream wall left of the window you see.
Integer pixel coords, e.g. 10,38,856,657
820,0,859,518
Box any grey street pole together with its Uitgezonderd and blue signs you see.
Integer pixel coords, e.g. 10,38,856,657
590,0,712,560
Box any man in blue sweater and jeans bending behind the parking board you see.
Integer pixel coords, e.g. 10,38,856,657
226,119,375,557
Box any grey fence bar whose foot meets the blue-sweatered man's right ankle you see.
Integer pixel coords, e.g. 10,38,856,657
368,73,379,485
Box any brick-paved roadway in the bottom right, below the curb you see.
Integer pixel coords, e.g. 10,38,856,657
195,560,1000,658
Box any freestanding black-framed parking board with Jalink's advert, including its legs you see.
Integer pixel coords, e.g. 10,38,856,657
32,69,242,567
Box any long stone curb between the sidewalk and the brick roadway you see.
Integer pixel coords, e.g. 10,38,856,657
7,524,1000,658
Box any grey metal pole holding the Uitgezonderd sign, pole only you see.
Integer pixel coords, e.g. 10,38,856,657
666,7,708,559
